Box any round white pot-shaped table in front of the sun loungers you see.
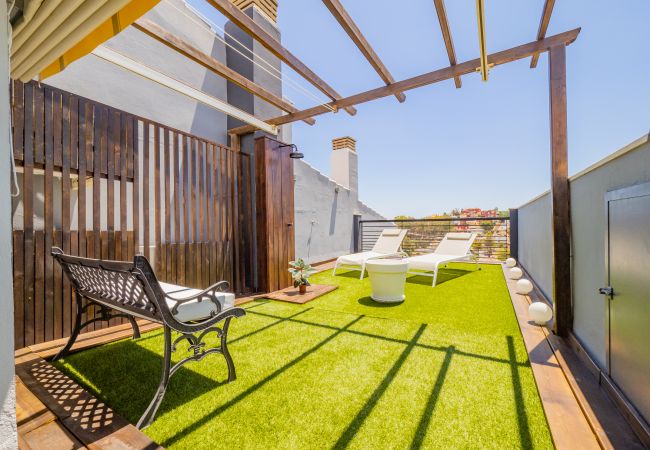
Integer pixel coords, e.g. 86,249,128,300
366,259,408,303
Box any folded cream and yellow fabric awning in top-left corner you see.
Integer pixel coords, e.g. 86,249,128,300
11,0,160,82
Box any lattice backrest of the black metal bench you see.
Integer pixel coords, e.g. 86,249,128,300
52,247,167,323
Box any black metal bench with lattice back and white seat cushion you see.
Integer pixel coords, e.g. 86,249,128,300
52,247,246,428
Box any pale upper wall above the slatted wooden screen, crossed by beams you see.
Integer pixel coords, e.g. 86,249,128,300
40,0,227,144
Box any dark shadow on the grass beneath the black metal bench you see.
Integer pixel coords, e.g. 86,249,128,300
54,335,220,423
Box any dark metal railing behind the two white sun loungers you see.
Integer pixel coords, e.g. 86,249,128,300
358,217,510,260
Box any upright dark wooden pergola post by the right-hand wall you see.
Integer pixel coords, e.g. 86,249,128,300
549,44,573,337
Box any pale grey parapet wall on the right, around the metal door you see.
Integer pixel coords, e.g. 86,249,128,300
519,135,650,368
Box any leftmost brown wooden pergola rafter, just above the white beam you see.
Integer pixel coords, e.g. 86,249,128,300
132,19,316,125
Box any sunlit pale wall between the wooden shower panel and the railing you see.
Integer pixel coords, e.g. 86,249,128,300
293,159,385,262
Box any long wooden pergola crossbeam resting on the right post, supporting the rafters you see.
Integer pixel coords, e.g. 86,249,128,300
229,28,580,134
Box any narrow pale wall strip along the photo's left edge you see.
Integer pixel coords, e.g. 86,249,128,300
0,2,18,449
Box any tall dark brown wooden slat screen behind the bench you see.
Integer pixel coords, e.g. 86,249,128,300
12,81,256,348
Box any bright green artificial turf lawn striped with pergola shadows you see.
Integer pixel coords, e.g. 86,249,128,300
57,264,553,449
